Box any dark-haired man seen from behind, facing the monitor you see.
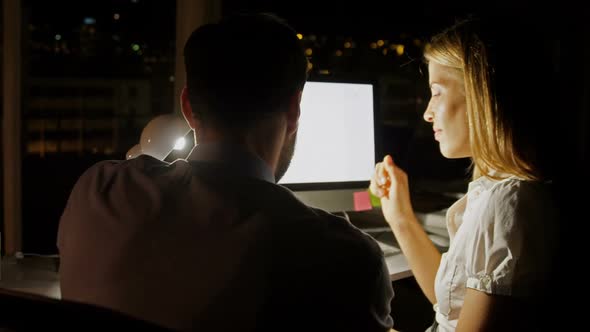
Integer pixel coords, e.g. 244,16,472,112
58,14,393,331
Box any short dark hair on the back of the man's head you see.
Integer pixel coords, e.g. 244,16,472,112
184,14,307,128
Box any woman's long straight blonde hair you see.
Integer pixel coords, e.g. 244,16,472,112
424,21,540,180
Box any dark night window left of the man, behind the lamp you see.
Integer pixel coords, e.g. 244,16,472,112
22,0,176,253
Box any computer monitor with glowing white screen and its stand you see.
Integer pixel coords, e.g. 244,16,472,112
279,81,380,212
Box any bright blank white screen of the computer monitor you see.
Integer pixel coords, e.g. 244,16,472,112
279,82,375,184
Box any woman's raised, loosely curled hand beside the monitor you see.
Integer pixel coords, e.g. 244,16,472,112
369,155,415,226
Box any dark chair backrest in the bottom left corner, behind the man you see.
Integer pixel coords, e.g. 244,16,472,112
0,289,171,331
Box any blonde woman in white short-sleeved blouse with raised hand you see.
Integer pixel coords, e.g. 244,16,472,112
370,20,557,331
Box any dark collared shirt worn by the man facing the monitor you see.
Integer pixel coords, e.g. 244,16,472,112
58,145,393,332
